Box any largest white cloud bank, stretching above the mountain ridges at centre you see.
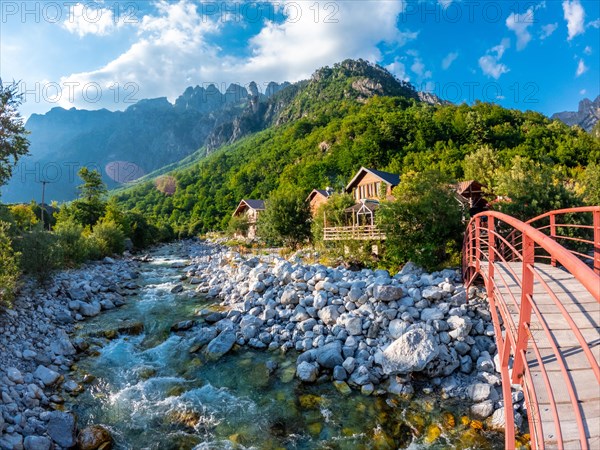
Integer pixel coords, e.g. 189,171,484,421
62,0,414,108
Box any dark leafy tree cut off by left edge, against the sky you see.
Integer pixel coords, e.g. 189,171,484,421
0,79,29,186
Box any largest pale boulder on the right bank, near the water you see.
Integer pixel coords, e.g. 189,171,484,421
383,327,439,375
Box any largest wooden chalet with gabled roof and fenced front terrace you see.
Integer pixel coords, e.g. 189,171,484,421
323,167,400,241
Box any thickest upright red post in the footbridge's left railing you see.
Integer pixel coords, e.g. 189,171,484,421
512,233,535,384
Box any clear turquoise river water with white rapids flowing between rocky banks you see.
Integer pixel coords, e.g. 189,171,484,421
68,248,504,450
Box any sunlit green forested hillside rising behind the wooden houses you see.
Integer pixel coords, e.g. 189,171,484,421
117,91,600,235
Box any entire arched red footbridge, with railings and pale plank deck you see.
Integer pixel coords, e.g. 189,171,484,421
463,206,600,450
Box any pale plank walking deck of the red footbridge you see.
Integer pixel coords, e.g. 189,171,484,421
481,262,600,450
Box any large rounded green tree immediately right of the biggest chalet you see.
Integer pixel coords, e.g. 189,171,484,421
377,171,464,269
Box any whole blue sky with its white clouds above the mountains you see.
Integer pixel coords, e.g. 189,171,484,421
0,0,600,116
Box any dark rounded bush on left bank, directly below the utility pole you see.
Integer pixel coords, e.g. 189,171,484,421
15,225,63,283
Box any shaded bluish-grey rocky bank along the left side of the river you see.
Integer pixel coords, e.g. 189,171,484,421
0,258,138,450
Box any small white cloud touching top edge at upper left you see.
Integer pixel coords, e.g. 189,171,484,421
62,3,124,37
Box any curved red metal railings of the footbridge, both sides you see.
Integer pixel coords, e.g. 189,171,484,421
463,206,600,449
